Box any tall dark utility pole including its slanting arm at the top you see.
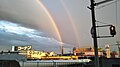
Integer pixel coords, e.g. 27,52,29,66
88,0,113,67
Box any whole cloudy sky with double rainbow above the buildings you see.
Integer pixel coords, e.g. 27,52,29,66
0,0,120,53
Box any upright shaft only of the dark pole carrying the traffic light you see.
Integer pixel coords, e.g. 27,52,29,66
91,0,99,67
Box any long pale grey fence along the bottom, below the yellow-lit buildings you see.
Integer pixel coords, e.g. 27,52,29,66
20,60,85,67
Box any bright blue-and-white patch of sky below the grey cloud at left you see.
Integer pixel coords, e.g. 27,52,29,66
0,20,73,53
